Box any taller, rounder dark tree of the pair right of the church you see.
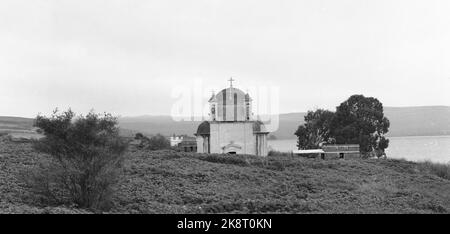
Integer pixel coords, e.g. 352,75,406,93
330,95,390,156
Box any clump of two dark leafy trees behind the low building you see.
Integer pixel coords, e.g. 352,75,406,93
295,95,390,157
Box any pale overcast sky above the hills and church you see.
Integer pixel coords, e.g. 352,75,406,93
0,0,450,117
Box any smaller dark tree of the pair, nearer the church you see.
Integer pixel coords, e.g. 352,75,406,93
295,109,334,149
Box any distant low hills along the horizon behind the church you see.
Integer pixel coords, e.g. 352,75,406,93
0,106,450,139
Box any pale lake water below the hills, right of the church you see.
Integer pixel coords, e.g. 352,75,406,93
268,136,450,163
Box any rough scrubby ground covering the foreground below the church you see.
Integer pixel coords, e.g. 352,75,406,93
0,141,450,213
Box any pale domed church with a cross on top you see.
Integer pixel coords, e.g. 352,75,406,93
195,79,269,156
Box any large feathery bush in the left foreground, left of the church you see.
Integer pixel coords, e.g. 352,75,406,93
26,110,126,209
